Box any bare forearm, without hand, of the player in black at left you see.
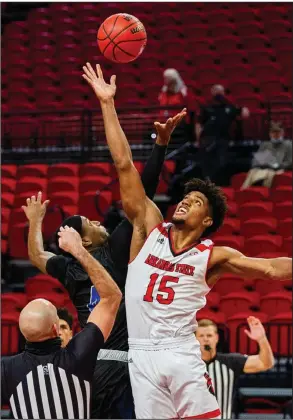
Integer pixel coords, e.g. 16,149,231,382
28,220,55,273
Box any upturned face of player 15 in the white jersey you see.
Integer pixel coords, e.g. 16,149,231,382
172,191,212,231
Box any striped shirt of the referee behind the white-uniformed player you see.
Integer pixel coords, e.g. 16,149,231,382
206,353,247,419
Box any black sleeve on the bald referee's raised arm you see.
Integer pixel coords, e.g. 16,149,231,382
66,322,105,379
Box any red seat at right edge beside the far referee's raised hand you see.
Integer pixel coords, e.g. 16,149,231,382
269,309,292,357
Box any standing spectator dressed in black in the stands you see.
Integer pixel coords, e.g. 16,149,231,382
195,85,249,184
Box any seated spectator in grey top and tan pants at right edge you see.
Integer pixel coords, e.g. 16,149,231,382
242,122,292,189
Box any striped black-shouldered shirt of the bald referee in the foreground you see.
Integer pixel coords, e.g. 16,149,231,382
1,323,104,419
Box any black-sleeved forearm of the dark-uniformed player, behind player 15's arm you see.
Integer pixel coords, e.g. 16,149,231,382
141,144,167,199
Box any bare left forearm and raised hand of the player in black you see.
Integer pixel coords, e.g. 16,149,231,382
22,192,55,274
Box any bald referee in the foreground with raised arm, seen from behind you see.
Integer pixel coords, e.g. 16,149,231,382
1,225,121,419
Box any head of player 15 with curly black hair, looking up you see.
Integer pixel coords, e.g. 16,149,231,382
172,178,227,238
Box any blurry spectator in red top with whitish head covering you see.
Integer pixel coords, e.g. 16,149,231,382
159,69,188,117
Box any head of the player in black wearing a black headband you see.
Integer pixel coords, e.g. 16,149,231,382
55,215,109,255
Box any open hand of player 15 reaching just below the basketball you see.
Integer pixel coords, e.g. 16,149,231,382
82,63,116,102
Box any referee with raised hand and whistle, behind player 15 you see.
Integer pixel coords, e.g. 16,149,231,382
195,316,274,419
